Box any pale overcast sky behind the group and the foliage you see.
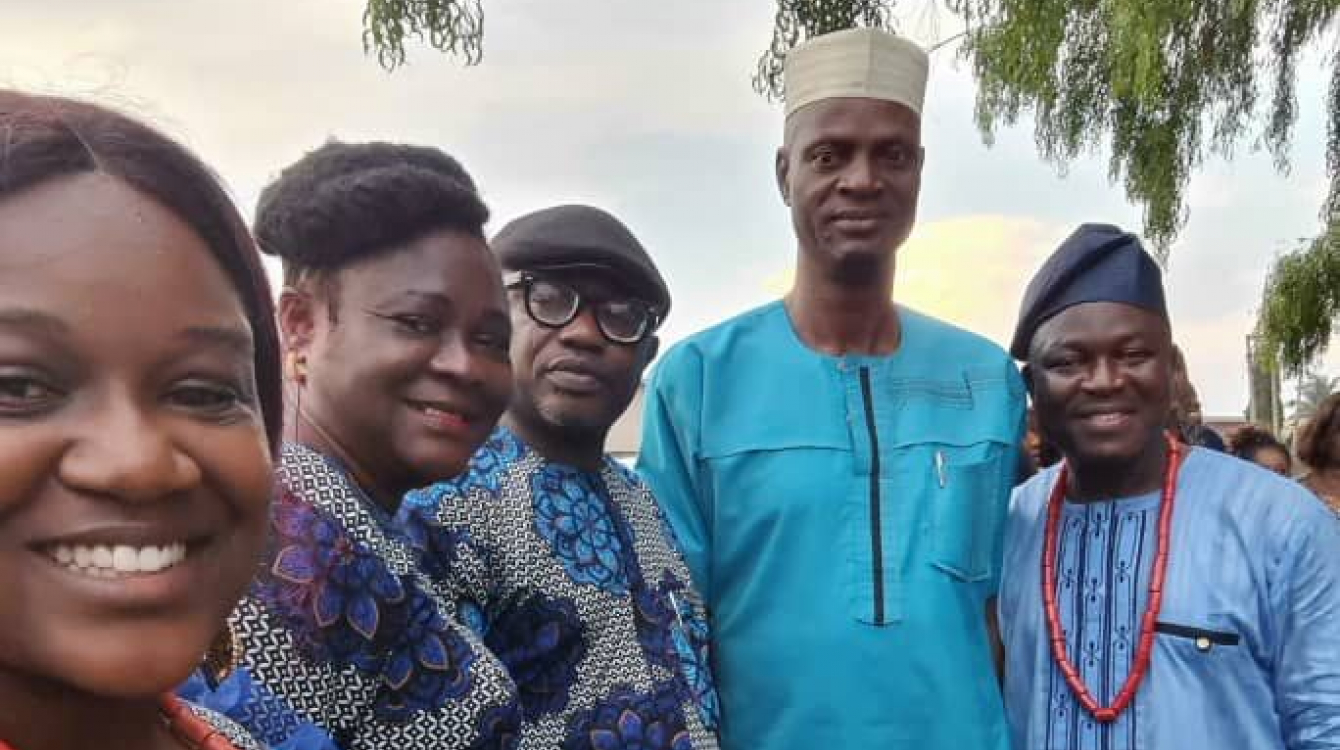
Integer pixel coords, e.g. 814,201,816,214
0,0,1340,415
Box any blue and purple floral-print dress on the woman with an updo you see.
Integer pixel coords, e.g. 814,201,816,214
180,445,521,750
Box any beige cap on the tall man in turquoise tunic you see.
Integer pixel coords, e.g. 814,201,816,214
785,28,930,117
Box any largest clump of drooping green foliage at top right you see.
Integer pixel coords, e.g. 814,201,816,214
947,0,1340,253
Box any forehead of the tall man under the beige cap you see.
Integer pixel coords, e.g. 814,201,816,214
787,98,921,145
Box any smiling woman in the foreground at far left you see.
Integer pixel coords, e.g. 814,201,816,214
0,90,283,750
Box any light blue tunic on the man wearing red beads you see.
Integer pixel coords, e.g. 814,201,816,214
1000,449,1340,750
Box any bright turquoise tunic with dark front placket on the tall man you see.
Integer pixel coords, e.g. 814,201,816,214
638,303,1024,750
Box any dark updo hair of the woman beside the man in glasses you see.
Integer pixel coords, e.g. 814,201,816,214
256,141,489,284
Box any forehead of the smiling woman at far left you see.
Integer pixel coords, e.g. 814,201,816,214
0,173,245,327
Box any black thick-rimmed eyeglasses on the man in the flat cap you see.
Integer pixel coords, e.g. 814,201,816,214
504,272,661,344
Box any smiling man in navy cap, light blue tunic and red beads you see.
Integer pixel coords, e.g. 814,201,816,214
1000,225,1340,750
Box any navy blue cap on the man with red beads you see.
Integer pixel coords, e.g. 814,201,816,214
1009,224,1168,360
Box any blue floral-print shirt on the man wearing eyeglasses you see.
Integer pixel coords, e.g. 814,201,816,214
398,427,718,750
